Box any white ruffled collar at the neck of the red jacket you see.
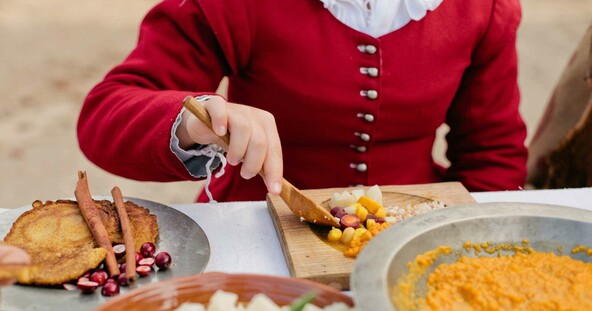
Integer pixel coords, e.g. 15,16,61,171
321,0,442,37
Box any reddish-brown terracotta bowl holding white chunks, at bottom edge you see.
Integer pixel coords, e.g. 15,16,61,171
97,272,353,311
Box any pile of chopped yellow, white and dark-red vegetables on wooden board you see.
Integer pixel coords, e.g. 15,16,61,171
327,185,446,257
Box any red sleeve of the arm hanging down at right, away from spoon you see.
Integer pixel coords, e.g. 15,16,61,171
445,0,527,191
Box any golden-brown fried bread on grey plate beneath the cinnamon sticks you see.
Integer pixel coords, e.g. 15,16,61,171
4,200,158,286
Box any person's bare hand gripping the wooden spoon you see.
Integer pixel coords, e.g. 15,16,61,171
176,96,283,194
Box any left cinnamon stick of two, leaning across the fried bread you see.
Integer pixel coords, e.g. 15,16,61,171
74,171,120,277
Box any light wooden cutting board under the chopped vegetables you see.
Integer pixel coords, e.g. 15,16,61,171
267,182,475,290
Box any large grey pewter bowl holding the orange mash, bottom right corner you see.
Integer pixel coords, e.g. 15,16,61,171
350,203,592,311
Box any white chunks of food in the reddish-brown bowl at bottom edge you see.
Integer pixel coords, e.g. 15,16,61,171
175,290,356,311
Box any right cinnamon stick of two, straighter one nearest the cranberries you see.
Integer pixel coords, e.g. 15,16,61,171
111,187,136,285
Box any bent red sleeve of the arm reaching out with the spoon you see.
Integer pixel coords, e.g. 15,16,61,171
77,0,230,181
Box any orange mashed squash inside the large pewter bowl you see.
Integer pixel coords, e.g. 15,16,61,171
392,242,592,310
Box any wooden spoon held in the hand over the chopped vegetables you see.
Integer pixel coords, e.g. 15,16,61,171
183,96,339,227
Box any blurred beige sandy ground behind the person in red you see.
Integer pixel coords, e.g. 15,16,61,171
0,0,592,208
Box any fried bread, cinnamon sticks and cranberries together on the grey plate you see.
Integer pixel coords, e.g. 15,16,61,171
4,173,164,296
